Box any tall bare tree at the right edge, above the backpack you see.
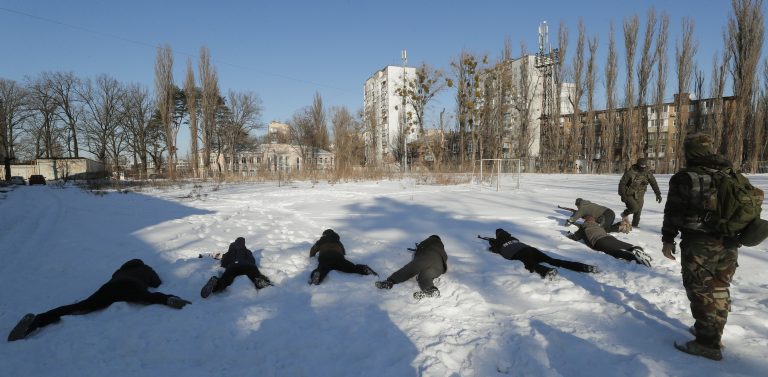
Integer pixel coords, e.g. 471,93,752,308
726,0,765,171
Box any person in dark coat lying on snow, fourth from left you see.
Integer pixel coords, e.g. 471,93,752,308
376,234,448,300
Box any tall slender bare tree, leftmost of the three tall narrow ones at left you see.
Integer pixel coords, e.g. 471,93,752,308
155,44,178,180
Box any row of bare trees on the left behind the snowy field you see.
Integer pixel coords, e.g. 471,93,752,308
0,45,262,179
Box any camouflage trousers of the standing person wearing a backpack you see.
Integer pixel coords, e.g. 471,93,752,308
680,239,738,348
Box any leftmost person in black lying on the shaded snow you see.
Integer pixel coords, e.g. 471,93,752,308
8,259,190,342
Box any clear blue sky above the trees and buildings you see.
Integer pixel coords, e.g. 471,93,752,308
0,0,765,149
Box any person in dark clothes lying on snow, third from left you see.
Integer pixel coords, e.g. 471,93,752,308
309,229,378,285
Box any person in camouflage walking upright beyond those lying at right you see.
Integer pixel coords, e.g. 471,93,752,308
619,158,661,226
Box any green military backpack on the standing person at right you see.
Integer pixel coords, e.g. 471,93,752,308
684,166,768,246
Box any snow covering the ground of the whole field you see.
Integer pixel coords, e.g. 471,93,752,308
0,175,768,377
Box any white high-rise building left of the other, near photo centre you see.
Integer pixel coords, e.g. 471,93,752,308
363,65,419,163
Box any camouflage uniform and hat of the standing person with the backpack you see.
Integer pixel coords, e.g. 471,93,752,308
662,134,739,352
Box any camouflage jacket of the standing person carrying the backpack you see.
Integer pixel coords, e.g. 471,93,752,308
661,155,731,242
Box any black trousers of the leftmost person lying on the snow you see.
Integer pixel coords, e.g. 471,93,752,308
29,279,170,331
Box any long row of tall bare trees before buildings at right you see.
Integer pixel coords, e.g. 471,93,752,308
388,0,768,172
